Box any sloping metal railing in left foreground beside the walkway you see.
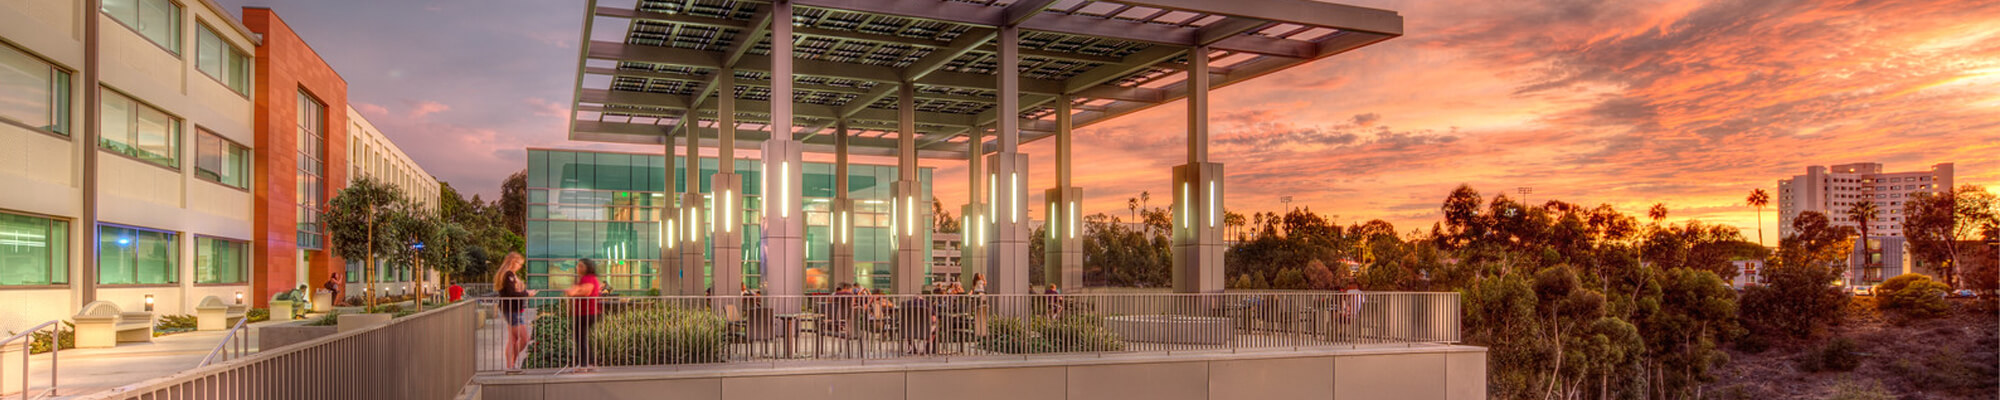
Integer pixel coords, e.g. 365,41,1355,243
94,302,476,400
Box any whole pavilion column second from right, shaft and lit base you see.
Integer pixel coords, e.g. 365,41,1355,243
1042,96,1084,288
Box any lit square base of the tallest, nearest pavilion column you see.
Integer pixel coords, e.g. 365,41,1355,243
756,136,806,308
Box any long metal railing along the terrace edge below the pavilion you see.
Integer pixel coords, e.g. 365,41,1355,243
476,292,1460,370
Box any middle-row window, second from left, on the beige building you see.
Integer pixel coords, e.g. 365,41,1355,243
98,90,180,170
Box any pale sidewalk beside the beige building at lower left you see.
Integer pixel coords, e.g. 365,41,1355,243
8,322,284,398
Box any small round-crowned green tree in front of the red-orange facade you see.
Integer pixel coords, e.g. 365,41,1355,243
322,176,406,310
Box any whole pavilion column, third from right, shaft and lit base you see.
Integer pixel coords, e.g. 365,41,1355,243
986,26,1030,294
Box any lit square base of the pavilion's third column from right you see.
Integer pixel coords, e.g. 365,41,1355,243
988,152,1032,294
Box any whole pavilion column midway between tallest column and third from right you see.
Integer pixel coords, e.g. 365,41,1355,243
890,82,934,294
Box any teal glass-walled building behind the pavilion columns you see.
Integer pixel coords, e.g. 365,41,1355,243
526,148,930,294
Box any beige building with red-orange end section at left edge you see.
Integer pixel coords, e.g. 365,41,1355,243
0,0,434,330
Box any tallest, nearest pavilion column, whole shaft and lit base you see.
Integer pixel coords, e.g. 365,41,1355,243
760,0,806,314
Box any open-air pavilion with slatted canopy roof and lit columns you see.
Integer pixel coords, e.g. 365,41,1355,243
570,0,1402,306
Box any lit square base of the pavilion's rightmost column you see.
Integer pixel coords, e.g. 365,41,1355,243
1174,162,1228,294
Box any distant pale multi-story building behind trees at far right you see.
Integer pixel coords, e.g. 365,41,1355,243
1776,162,1952,286
